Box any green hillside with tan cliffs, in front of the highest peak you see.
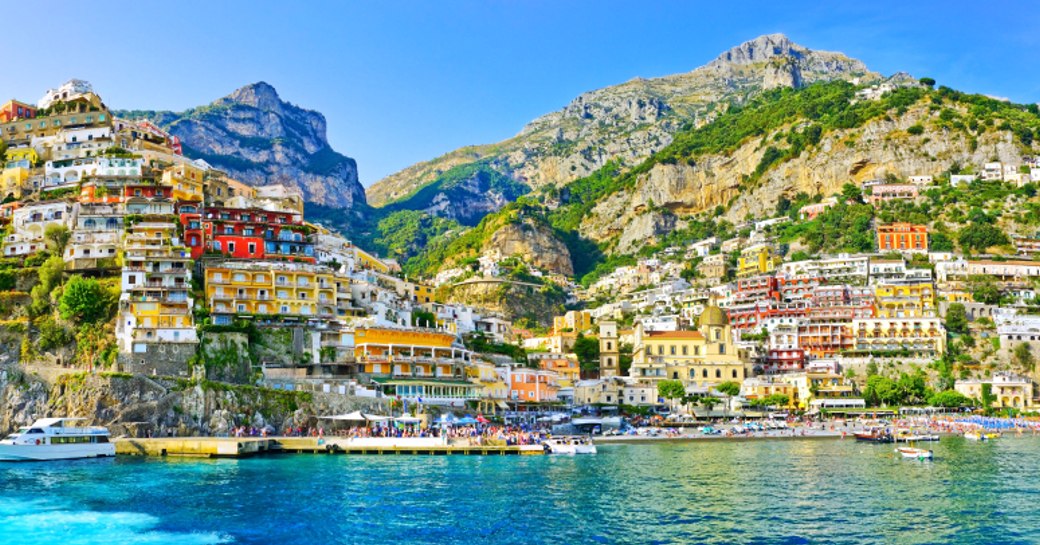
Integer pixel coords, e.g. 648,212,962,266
391,82,1040,284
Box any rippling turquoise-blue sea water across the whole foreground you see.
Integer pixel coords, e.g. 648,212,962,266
0,437,1040,545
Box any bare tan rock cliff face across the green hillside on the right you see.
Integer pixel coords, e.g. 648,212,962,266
579,104,1022,254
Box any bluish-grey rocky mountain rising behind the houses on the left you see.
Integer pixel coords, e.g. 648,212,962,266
118,81,365,207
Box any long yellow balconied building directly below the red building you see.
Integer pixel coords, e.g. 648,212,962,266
205,261,341,325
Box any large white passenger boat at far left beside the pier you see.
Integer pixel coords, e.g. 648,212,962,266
0,418,115,462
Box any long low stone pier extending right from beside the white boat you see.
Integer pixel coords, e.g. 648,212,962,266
113,437,545,458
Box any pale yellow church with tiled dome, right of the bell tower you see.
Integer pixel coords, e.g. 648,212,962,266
629,306,747,389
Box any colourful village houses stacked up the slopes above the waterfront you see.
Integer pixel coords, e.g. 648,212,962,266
0,80,1040,413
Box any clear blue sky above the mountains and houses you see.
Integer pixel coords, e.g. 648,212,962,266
0,0,1040,185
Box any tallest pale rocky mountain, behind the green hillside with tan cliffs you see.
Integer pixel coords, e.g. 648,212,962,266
367,34,881,217
